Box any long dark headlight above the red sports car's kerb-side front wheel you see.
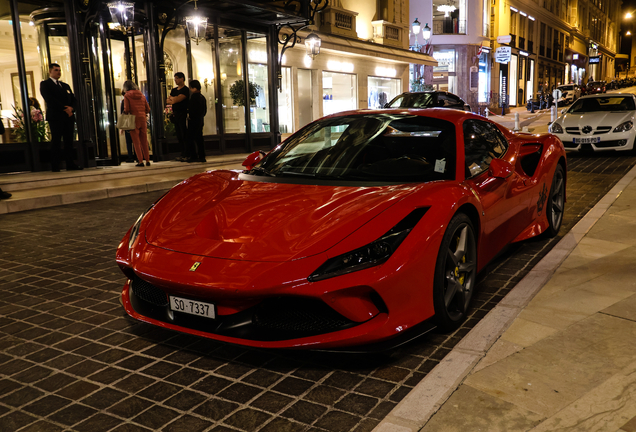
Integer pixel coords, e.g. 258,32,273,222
307,207,428,282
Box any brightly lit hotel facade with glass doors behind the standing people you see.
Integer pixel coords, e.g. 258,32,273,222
0,0,435,172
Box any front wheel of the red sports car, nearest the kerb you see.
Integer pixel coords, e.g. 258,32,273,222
433,213,477,331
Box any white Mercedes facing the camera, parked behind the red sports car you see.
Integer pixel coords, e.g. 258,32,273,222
550,93,636,151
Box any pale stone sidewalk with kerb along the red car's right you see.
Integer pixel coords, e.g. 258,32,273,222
374,158,636,432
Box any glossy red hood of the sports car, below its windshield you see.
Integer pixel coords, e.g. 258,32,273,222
145,171,418,262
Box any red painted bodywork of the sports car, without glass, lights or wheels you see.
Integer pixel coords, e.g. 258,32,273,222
117,109,566,349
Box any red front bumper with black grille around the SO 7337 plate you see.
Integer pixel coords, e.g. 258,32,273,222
118,231,434,351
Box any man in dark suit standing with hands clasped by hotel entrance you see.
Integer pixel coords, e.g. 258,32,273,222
40,63,82,172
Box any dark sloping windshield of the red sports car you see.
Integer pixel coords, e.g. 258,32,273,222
249,114,455,182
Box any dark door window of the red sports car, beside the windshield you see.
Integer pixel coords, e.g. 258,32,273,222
464,120,508,177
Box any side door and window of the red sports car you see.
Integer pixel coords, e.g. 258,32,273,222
463,119,531,262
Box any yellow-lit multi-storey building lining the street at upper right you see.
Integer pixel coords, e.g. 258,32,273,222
491,0,620,106
